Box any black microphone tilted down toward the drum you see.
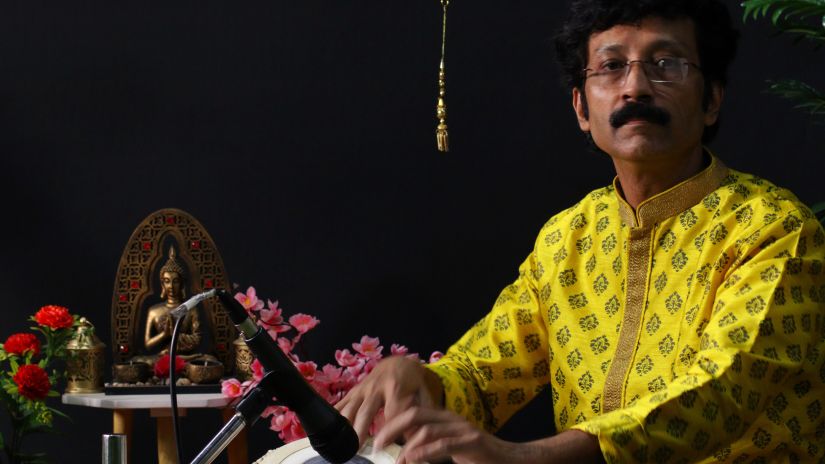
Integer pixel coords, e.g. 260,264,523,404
212,289,359,464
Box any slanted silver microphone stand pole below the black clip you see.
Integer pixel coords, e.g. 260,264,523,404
191,371,277,464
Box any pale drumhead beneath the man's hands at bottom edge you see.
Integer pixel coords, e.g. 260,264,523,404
254,438,401,464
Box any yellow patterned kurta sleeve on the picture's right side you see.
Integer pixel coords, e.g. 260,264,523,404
575,211,825,462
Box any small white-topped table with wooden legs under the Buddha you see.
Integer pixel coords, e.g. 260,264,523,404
63,393,249,464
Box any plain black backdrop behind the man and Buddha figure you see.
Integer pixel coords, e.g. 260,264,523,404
0,0,825,462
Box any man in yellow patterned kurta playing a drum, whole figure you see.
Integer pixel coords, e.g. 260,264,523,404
337,0,825,463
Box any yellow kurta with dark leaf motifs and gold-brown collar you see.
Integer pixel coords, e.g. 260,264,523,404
430,158,825,462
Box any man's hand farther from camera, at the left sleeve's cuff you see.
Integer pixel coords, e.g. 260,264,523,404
335,356,443,444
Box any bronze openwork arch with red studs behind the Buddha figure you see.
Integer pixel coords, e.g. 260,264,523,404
112,208,236,366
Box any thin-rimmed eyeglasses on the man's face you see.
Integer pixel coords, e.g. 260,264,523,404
582,57,702,87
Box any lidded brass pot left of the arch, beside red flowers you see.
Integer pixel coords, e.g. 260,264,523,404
66,317,106,393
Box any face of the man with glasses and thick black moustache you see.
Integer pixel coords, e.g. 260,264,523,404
573,17,722,162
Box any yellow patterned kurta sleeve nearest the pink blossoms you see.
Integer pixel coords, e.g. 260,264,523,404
427,248,549,432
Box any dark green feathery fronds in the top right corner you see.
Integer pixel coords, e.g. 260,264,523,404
742,0,825,117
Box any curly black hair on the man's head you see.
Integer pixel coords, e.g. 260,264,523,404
555,0,739,142
